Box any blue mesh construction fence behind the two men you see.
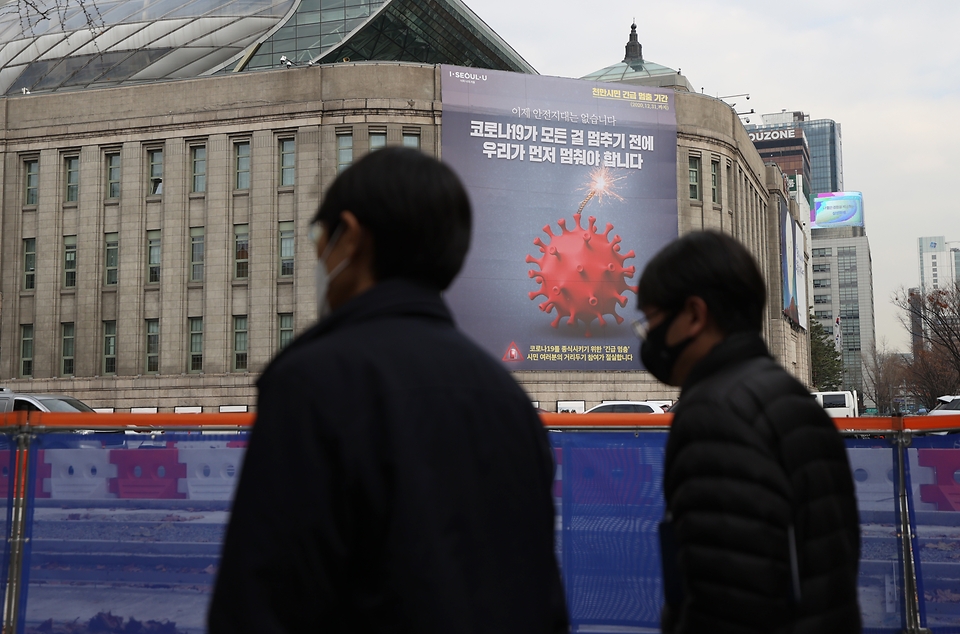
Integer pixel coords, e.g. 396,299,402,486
0,414,960,634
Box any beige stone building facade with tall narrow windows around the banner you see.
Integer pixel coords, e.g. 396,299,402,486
0,62,809,411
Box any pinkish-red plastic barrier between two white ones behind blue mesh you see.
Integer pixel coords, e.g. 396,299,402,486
108,449,187,500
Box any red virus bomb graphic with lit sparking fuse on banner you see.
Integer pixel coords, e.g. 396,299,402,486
526,167,637,337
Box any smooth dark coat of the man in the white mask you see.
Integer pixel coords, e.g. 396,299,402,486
209,280,568,634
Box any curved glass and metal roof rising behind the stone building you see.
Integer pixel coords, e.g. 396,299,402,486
0,0,536,95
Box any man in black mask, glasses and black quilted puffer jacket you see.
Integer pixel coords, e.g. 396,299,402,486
635,232,862,634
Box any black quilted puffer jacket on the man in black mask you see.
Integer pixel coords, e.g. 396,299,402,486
663,333,861,634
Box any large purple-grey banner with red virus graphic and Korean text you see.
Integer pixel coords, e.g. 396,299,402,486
440,66,677,370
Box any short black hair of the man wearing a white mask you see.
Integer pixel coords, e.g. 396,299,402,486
313,147,471,290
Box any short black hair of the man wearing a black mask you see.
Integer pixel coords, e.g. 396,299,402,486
637,231,767,334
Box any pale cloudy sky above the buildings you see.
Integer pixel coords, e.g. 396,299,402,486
465,0,960,351
